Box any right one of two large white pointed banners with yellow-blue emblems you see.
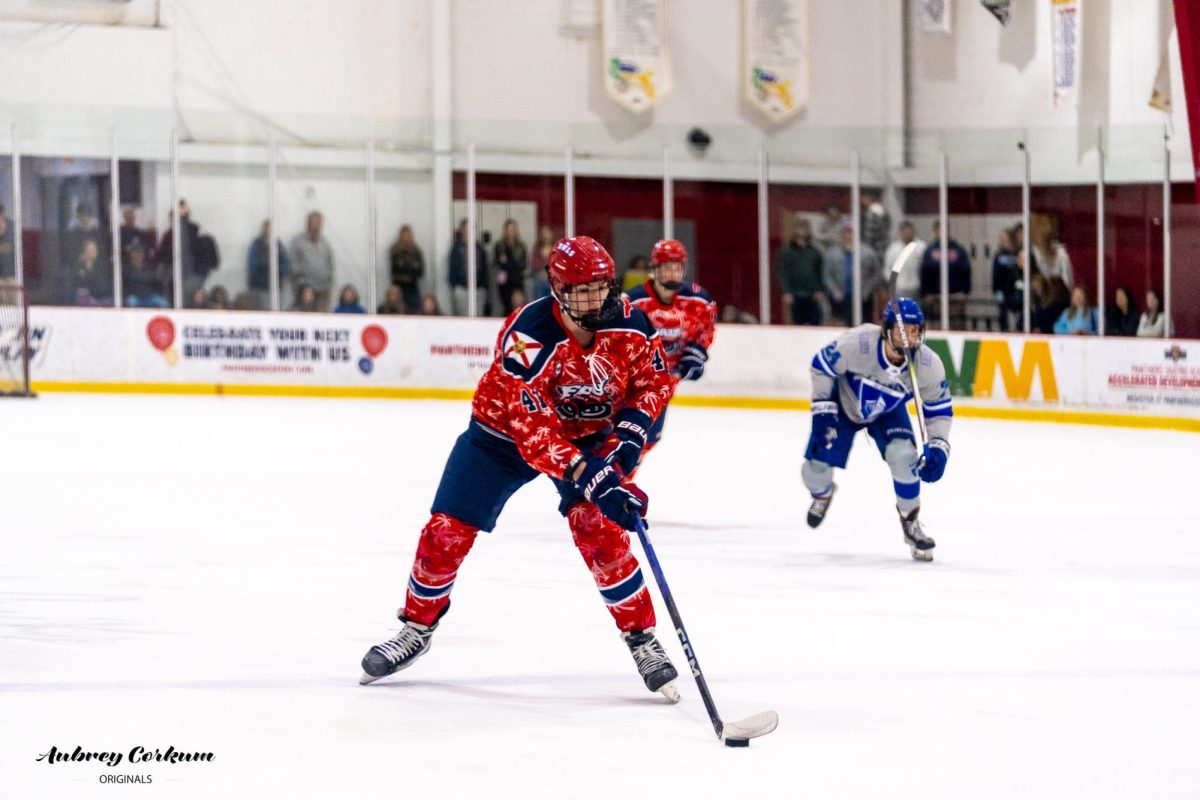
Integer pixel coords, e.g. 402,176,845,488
742,0,809,122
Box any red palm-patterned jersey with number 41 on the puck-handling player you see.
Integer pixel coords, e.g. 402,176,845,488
472,297,673,477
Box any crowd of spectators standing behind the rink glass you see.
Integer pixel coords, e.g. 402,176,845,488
11,190,1165,337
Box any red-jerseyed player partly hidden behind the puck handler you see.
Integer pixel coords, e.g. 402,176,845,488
628,239,716,456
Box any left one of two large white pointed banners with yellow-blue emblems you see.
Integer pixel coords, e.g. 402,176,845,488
602,0,673,112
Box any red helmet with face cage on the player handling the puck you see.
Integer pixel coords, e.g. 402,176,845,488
546,236,620,331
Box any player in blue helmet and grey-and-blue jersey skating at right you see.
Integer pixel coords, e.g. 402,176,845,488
800,297,954,561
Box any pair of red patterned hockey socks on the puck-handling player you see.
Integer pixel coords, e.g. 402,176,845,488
403,503,654,631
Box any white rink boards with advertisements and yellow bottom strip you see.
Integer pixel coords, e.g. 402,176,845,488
11,307,1200,431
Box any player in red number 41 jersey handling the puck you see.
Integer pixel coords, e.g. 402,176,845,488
361,236,679,700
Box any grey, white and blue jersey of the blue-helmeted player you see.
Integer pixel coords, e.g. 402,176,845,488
812,324,954,440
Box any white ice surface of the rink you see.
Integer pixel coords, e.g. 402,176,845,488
0,395,1200,800
